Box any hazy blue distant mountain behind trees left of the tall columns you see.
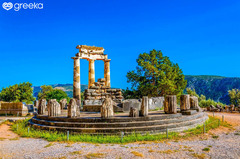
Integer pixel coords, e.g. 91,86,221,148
33,84,88,98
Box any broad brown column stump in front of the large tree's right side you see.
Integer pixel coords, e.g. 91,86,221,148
164,95,177,114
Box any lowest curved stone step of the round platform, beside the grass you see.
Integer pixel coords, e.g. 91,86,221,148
30,115,208,134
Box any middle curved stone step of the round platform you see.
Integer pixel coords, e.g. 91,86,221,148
32,113,204,128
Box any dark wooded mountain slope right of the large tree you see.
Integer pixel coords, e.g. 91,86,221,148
185,75,240,104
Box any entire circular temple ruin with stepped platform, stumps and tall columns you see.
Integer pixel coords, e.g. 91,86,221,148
29,45,208,135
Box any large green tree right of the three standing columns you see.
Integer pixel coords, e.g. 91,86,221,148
127,50,187,97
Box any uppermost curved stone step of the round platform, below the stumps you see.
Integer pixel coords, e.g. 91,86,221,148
37,113,183,123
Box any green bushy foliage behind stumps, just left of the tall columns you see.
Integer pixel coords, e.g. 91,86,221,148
38,85,69,102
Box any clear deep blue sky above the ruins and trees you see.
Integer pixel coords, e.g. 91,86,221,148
0,0,240,88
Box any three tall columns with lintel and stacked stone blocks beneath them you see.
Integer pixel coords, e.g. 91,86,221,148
72,45,123,112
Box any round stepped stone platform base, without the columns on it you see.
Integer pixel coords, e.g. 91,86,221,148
30,111,208,134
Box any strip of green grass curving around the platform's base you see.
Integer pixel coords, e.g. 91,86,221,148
11,117,231,144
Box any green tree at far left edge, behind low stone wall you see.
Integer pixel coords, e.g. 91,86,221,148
0,82,35,104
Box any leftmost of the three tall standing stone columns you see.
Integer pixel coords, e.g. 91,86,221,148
72,57,81,103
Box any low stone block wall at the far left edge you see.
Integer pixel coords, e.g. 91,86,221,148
0,102,28,116
